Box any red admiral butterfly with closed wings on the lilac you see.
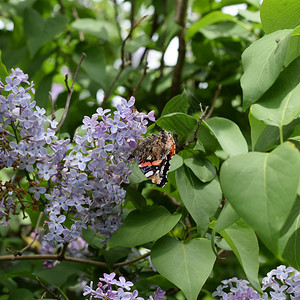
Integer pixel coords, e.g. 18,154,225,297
130,130,175,187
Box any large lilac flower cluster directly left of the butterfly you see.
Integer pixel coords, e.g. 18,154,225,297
45,97,154,244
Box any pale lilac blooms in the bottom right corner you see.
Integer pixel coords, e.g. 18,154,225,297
212,265,300,300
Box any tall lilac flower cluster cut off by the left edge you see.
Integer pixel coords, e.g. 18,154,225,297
0,68,57,219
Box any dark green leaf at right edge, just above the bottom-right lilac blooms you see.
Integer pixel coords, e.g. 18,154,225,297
279,196,300,270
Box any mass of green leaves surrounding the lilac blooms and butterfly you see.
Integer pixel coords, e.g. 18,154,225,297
0,0,300,300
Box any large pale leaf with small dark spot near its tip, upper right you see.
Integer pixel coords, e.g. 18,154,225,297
241,29,292,109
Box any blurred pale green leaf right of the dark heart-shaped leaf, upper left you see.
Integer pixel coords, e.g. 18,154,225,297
71,18,109,41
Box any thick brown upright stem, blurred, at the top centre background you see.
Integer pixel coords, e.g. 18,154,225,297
170,0,188,98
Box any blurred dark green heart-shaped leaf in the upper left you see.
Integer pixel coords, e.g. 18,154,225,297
24,8,68,57
